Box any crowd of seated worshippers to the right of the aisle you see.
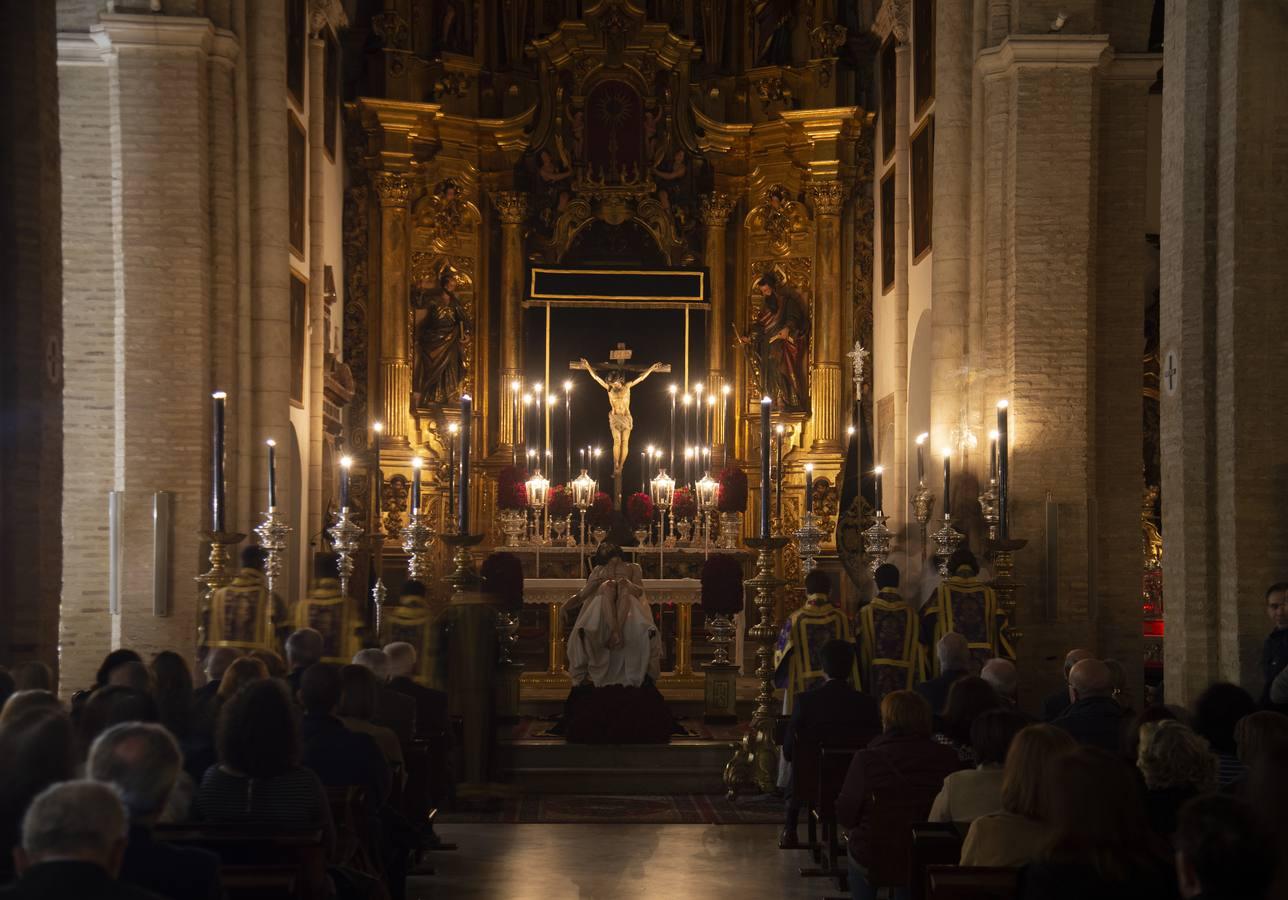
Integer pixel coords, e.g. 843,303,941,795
779,565,1288,900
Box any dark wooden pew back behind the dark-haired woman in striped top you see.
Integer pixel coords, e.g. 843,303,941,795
156,824,331,900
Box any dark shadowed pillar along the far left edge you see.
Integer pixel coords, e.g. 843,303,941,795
0,3,62,664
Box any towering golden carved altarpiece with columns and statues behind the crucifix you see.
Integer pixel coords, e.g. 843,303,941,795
345,0,872,690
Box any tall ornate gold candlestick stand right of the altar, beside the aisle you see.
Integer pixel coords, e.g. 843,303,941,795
724,537,787,800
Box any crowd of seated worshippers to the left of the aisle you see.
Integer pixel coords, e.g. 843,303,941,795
0,628,452,900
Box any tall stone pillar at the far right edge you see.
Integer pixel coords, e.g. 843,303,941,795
1160,0,1288,703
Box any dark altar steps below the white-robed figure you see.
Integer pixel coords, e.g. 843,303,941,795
497,738,732,794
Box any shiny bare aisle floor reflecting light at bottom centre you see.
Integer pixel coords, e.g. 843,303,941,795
407,824,837,900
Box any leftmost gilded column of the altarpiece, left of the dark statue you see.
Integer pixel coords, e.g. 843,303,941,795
374,173,411,447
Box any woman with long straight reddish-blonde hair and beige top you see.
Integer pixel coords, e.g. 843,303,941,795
961,725,1075,868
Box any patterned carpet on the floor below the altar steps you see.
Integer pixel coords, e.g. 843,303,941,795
438,793,783,825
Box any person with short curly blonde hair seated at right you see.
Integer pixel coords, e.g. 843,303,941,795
1136,718,1217,838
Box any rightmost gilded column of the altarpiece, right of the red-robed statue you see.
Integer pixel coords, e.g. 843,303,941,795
805,179,845,453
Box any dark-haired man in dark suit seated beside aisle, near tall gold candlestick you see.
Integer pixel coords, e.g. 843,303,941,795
778,639,881,850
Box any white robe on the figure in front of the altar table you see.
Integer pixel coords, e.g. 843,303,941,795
568,561,662,688
